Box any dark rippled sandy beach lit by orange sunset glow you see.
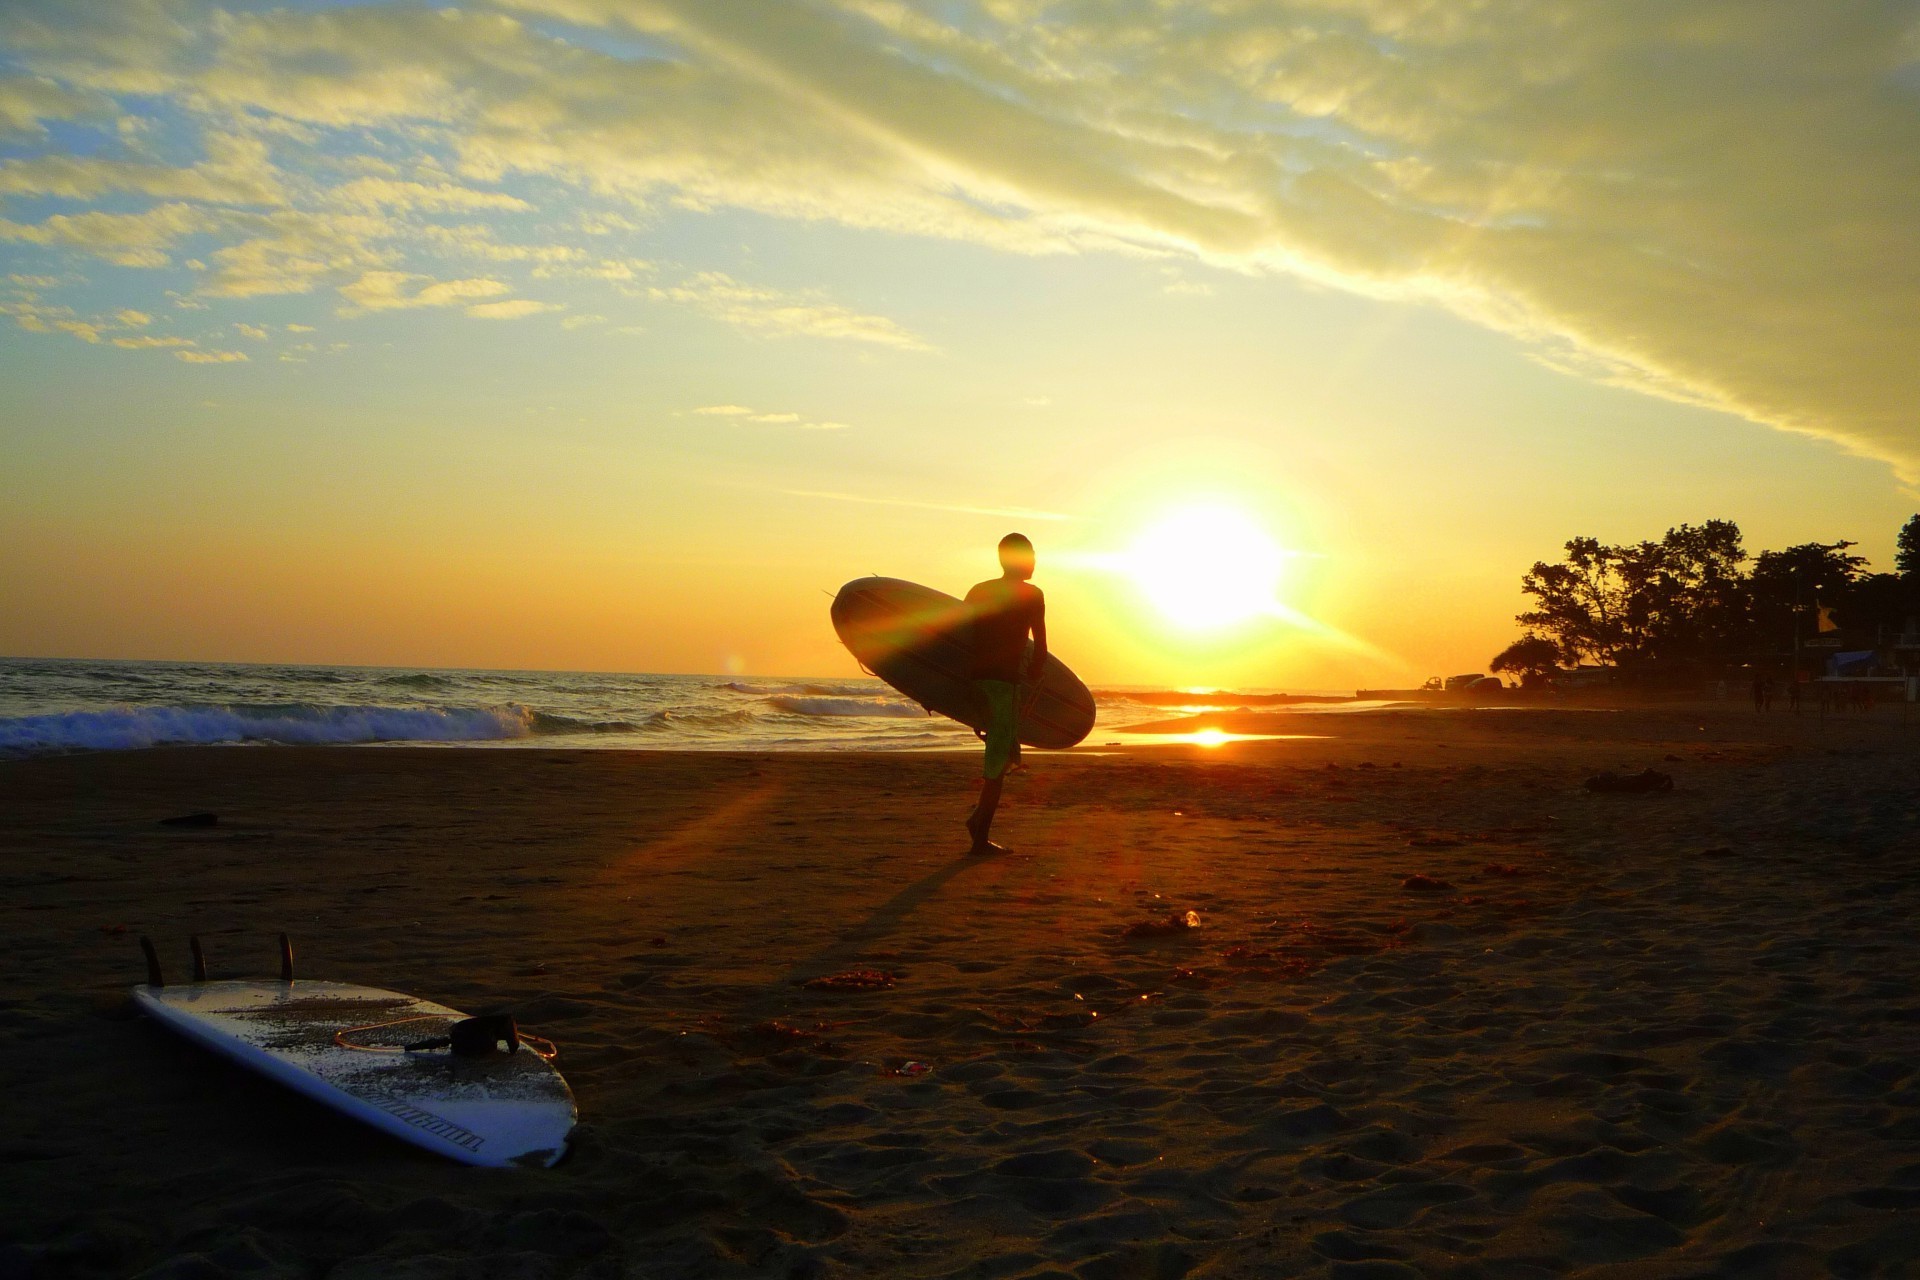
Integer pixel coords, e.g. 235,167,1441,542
0,704,1920,1280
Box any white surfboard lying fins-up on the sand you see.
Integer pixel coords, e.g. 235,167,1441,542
132,979,576,1167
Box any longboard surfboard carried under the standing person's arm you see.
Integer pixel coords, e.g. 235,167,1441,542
833,578,1094,748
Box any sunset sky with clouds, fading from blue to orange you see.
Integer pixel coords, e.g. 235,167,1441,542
0,0,1920,689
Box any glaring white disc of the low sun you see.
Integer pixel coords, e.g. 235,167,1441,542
1123,507,1286,631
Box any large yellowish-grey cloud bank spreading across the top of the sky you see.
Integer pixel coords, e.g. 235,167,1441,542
0,0,1920,470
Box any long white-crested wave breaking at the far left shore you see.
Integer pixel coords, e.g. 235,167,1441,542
0,702,533,754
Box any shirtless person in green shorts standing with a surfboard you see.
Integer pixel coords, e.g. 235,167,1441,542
966,533,1046,854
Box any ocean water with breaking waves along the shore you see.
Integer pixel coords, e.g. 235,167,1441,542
0,658,1351,756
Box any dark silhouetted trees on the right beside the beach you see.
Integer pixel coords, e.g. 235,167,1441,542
1492,514,1920,679
